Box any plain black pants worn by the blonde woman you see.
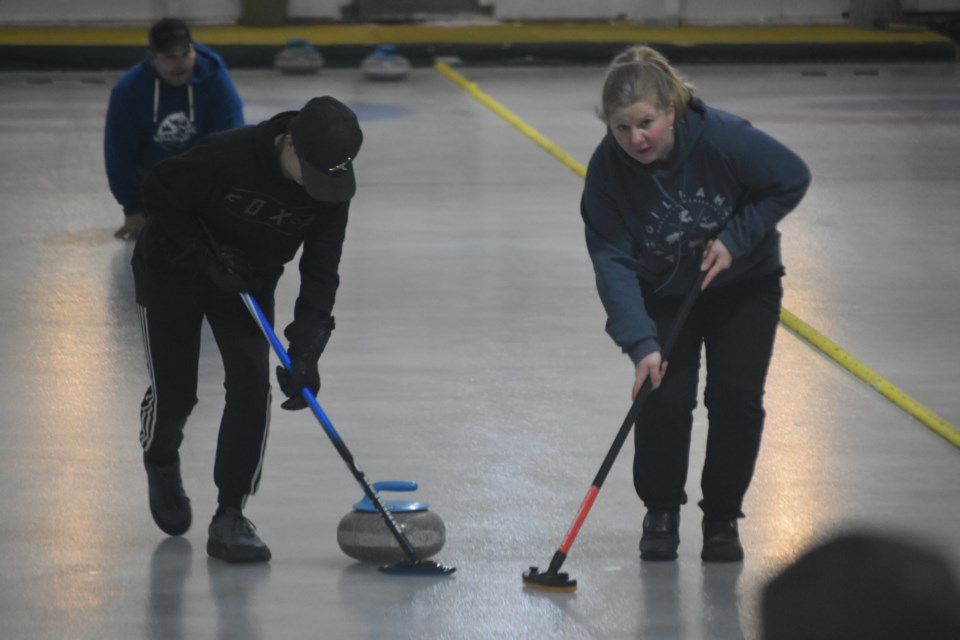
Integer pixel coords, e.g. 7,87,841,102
633,273,783,519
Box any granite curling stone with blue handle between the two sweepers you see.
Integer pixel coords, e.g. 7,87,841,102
337,480,447,563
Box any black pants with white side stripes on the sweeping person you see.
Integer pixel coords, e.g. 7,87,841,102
134,258,277,508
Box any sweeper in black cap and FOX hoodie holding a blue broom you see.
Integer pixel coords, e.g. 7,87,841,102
133,96,363,562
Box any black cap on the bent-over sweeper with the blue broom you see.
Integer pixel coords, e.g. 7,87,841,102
290,96,363,202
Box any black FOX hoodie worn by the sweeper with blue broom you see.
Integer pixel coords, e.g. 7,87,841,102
134,111,350,342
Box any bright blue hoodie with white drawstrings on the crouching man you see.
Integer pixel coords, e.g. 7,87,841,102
103,43,244,215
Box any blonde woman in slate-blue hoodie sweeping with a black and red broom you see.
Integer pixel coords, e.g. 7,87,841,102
581,46,810,562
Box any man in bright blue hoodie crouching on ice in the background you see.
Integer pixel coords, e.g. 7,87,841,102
103,18,244,240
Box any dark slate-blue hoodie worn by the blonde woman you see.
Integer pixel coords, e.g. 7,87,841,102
580,100,810,363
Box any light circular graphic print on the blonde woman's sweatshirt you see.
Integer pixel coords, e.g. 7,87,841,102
643,187,733,264
